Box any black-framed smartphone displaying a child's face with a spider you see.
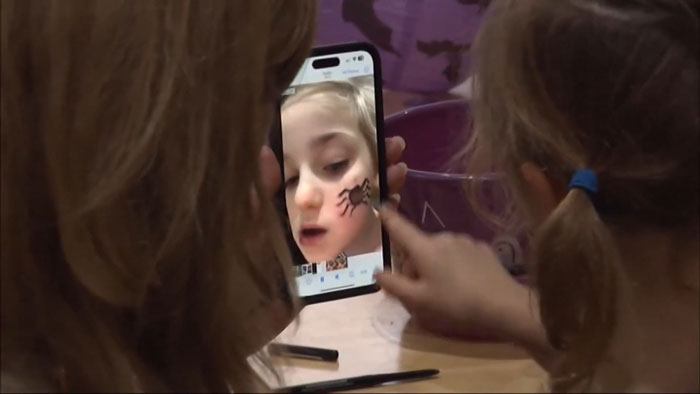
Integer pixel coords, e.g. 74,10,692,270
270,43,391,304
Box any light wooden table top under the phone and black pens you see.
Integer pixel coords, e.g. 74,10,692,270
274,292,546,392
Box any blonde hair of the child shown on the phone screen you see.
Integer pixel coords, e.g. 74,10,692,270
282,76,379,172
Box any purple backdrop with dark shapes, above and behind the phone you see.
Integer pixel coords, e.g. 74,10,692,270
316,0,485,93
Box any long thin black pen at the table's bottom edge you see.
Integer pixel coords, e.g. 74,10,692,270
276,369,440,393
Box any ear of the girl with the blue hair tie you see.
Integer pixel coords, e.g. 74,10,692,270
520,162,565,223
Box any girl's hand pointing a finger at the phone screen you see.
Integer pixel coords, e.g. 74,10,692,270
376,208,539,339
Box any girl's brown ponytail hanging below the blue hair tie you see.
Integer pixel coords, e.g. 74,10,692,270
535,172,619,391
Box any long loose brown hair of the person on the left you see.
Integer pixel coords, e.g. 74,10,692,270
1,0,315,391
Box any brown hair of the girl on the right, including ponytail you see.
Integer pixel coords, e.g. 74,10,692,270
472,0,700,390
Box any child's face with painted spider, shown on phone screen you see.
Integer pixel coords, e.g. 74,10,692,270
282,94,381,262
